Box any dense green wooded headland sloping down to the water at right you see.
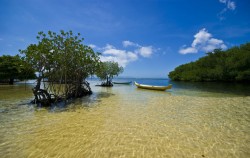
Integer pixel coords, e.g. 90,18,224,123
168,43,250,82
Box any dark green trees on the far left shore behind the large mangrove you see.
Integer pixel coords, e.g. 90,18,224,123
0,55,36,84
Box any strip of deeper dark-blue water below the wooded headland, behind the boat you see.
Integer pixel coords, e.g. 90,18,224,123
129,78,250,96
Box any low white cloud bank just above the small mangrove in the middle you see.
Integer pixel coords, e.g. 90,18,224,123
89,40,155,67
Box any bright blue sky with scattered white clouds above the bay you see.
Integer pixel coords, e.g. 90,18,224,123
0,0,250,78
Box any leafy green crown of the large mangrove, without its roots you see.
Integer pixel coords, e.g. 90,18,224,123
21,31,99,79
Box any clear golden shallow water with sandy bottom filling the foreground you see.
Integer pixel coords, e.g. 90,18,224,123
0,81,250,157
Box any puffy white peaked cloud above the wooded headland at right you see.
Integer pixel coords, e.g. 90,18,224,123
179,28,227,54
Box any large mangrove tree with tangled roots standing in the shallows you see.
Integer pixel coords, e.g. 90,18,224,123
20,31,100,105
